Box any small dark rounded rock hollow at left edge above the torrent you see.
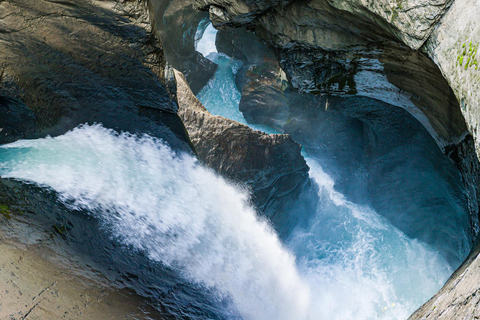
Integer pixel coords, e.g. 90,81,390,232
0,96,35,144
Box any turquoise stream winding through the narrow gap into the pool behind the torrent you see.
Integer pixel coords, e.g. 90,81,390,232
191,21,460,319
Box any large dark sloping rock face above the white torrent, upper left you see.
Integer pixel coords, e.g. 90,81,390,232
0,0,190,150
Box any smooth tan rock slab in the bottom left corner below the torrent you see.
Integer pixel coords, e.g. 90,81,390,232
0,214,163,320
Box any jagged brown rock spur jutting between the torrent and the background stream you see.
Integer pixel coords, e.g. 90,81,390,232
175,71,315,235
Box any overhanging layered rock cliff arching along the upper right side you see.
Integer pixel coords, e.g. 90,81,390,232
190,0,480,319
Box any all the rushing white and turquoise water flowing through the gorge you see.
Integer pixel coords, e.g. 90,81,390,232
0,20,468,320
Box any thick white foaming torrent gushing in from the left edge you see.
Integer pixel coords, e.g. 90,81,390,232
0,125,310,320
